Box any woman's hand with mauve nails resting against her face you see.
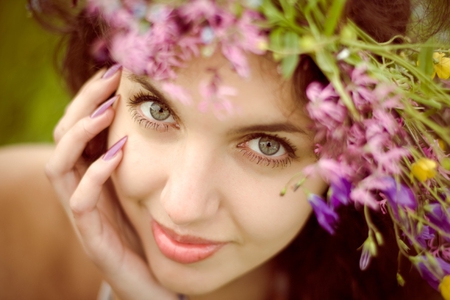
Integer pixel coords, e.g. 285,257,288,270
46,66,178,300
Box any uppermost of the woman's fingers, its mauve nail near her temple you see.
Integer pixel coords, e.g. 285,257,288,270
53,65,121,142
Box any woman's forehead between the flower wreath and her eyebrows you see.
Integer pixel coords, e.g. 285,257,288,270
125,53,309,125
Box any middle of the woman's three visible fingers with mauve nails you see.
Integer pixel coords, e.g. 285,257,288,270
46,95,119,181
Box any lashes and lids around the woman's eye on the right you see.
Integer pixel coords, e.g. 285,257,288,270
238,133,297,168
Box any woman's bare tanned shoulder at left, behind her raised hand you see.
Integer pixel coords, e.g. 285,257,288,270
0,145,100,299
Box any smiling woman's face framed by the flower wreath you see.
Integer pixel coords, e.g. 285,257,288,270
109,55,324,294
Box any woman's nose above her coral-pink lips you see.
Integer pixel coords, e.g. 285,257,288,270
160,138,220,225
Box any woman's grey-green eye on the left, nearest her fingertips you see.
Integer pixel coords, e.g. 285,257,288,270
128,92,178,132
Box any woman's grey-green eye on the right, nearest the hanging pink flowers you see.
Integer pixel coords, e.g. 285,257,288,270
237,133,297,168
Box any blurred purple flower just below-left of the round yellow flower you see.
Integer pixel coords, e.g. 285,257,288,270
382,177,417,216
